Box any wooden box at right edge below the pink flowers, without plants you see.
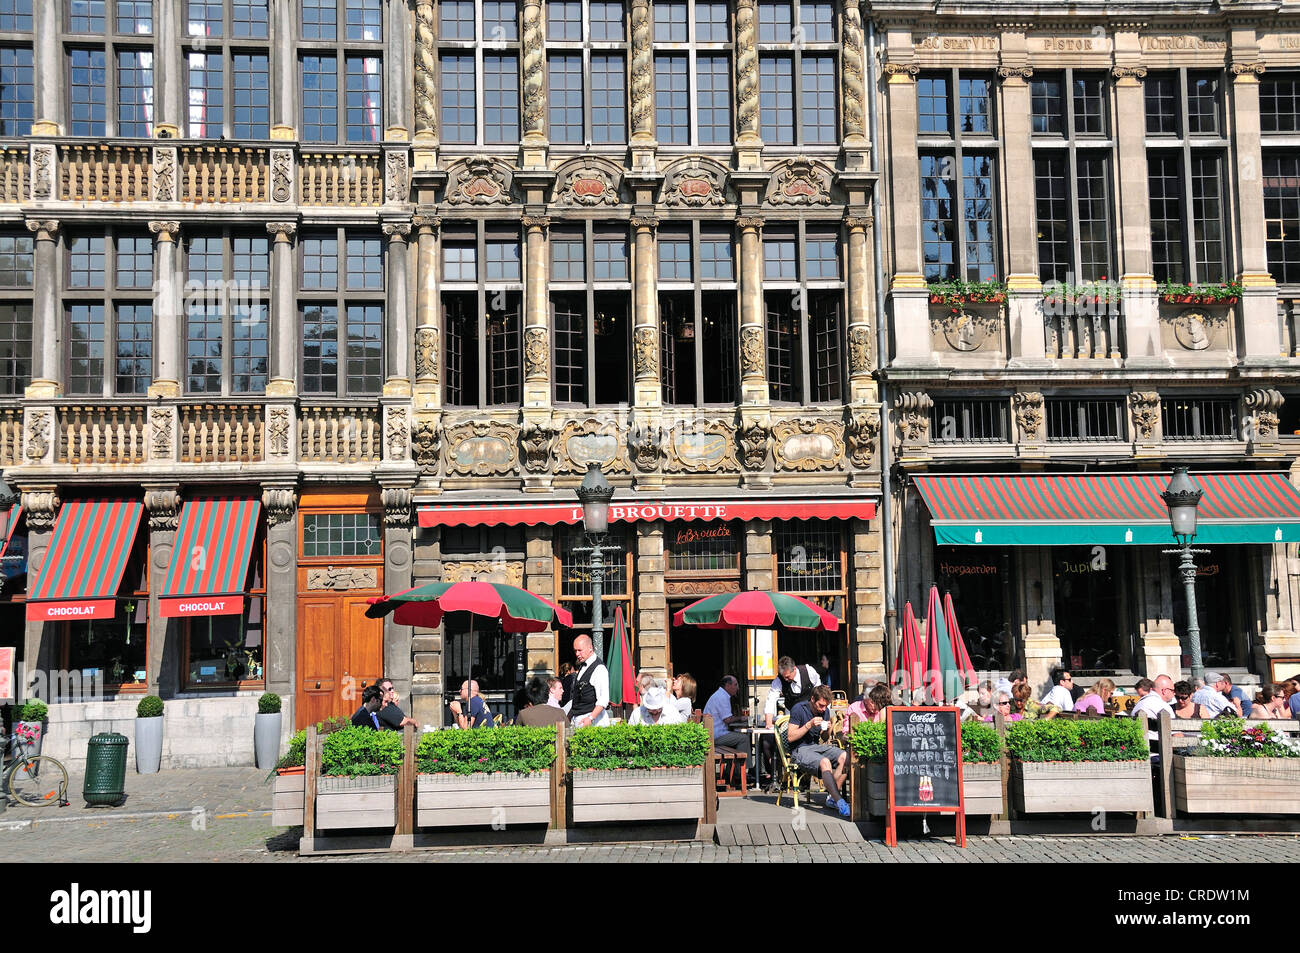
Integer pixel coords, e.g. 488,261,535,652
1173,754,1300,814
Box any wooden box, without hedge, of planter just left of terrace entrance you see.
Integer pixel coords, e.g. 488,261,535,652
569,767,705,823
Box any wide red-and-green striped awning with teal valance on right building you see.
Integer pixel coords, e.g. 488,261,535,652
915,473,1300,546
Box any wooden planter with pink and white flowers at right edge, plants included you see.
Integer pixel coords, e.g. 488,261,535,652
1171,718,1300,814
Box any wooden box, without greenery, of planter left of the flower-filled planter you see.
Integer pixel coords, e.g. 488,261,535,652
1010,759,1156,814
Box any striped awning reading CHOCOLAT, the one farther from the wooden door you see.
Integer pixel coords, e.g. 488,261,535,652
27,499,144,621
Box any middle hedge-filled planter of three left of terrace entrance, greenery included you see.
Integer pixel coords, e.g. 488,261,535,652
416,725,556,827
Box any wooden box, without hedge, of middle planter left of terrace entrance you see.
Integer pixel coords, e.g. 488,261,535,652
415,771,551,827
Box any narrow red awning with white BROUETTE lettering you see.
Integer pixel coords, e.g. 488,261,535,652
419,499,876,528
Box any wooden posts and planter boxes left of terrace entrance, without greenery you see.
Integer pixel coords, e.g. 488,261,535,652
284,716,718,854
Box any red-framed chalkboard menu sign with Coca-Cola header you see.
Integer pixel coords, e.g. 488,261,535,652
885,706,966,846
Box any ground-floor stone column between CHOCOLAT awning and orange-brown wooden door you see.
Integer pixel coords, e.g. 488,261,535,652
261,482,298,731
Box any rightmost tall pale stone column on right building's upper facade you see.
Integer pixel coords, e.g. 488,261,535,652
1231,55,1282,364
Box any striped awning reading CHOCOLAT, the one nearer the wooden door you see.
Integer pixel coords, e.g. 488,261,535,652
159,499,261,619
